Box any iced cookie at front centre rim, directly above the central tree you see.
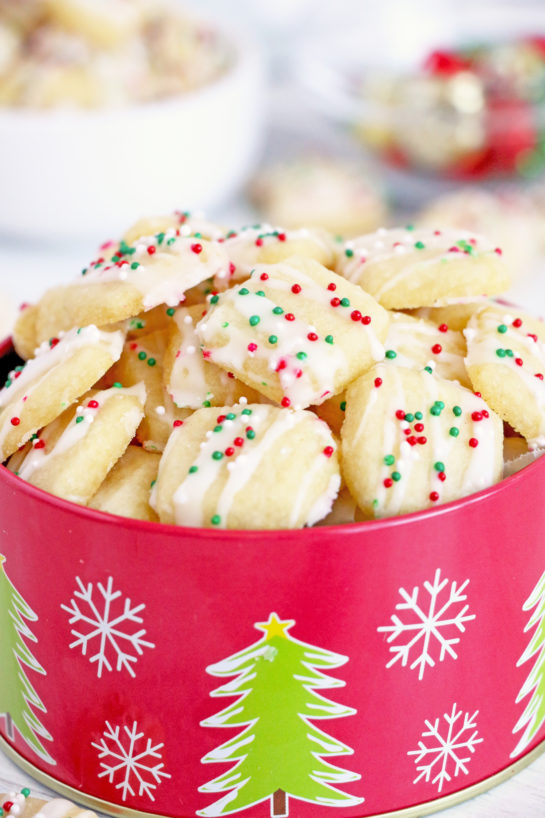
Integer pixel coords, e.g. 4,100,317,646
151,404,341,529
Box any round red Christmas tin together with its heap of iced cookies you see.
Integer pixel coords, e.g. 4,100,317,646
0,212,545,818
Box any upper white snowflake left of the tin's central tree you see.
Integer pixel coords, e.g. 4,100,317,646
61,577,155,679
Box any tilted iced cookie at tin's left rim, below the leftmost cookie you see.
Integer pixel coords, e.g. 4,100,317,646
9,384,146,505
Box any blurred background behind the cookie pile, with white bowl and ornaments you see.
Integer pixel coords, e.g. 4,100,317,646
0,0,545,329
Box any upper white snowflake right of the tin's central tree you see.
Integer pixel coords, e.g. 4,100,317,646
377,568,475,679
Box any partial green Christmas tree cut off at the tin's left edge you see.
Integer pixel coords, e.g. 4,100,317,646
0,554,55,764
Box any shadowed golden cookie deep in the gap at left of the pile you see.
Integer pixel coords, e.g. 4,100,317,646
108,330,190,452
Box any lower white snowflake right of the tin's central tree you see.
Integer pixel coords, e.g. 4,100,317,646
407,704,483,792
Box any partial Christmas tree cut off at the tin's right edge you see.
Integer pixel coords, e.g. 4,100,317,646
511,574,545,756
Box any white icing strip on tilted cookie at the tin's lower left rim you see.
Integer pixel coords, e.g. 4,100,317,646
18,383,146,480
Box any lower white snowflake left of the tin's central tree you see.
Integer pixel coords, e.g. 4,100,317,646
91,721,171,801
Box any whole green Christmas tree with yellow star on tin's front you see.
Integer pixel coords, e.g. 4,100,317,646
197,613,363,816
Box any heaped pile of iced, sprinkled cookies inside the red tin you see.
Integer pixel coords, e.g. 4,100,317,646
0,212,545,529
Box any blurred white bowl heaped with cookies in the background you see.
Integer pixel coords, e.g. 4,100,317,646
0,0,264,242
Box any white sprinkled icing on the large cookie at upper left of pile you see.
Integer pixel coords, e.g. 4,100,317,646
74,233,229,310
